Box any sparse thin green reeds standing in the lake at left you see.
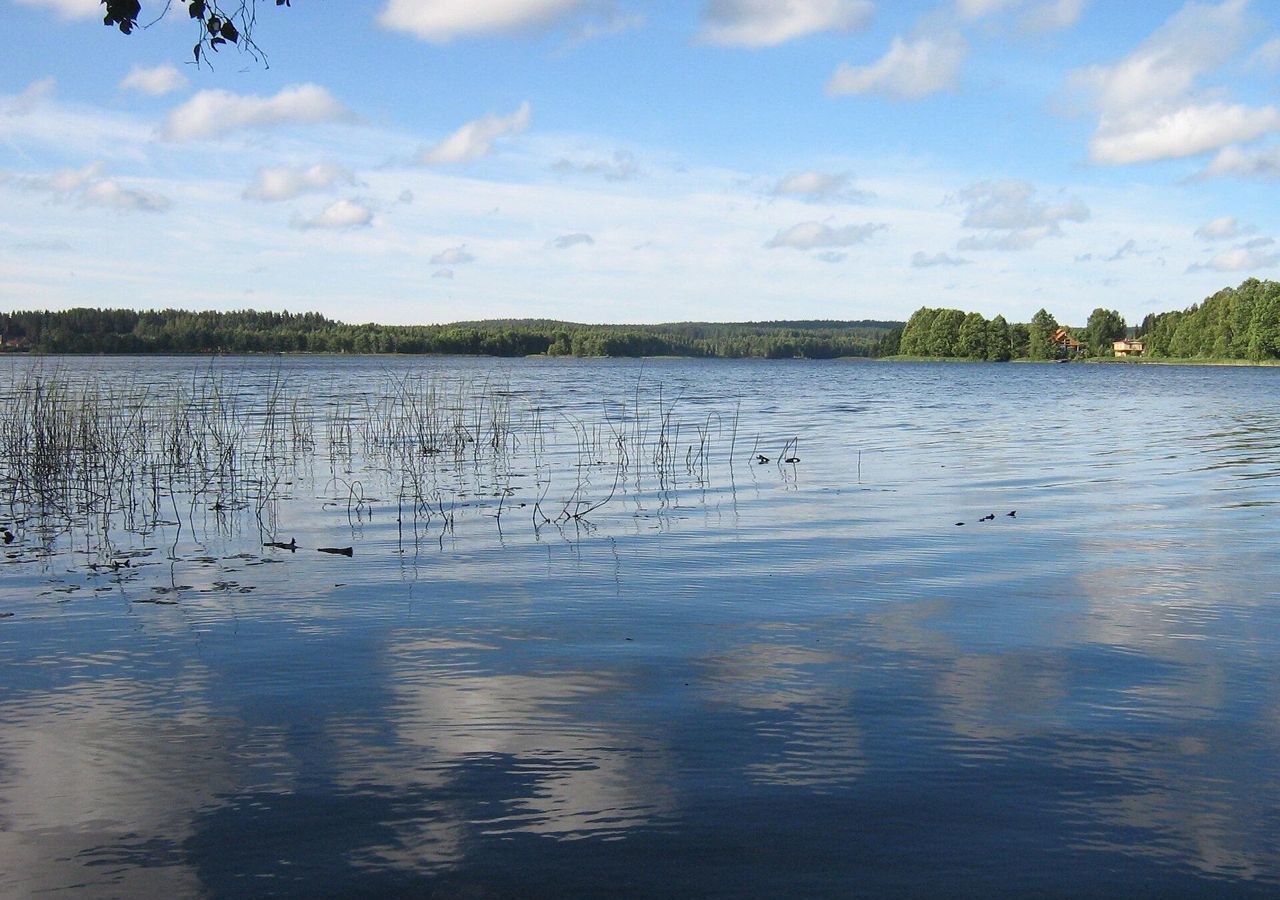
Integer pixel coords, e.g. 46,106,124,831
0,369,752,553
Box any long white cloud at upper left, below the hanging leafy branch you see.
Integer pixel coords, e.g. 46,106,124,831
160,84,352,141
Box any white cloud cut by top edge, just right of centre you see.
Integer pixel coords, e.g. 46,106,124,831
699,0,876,47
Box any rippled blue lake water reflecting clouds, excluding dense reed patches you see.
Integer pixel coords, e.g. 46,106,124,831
0,357,1280,897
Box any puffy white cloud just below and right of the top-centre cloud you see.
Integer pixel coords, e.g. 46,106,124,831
827,35,969,100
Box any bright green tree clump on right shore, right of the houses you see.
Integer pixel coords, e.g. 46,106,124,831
1139,278,1280,361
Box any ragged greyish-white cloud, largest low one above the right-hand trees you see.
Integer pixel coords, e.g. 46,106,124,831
951,179,1089,250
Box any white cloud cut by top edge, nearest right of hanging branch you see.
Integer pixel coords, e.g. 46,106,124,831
378,0,589,44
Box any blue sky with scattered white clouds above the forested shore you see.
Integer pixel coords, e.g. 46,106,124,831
0,0,1280,325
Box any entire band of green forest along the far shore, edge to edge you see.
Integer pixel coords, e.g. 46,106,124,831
0,278,1280,361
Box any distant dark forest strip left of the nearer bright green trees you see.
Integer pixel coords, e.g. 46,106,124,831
0,309,901,358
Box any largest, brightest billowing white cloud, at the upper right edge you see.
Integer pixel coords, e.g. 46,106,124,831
1071,0,1280,165
